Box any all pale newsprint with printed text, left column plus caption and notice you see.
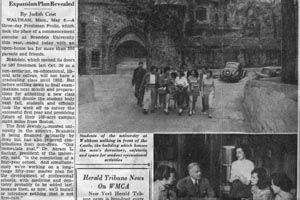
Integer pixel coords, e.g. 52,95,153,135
0,0,153,200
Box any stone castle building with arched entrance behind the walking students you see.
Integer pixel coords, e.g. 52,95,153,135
78,0,280,74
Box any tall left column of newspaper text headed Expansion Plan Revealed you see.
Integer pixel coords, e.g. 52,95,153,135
1,1,76,199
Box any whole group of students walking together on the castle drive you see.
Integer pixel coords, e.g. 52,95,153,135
132,62,215,118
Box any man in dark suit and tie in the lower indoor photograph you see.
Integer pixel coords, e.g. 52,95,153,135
176,163,215,198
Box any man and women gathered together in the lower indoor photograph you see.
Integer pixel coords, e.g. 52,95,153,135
153,146,296,200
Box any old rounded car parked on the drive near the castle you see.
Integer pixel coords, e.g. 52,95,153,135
220,62,247,83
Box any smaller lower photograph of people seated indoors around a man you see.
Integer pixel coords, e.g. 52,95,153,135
153,134,298,200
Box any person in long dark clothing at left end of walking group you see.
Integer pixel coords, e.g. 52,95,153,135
132,62,146,106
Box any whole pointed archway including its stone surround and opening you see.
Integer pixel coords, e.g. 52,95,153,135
109,26,150,74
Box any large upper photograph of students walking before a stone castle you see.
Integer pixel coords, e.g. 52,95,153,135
78,0,298,133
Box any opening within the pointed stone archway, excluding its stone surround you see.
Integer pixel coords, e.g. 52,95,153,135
116,40,147,74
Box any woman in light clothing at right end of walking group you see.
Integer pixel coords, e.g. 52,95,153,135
201,70,215,118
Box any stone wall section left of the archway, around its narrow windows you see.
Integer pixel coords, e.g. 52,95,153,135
79,3,130,74
